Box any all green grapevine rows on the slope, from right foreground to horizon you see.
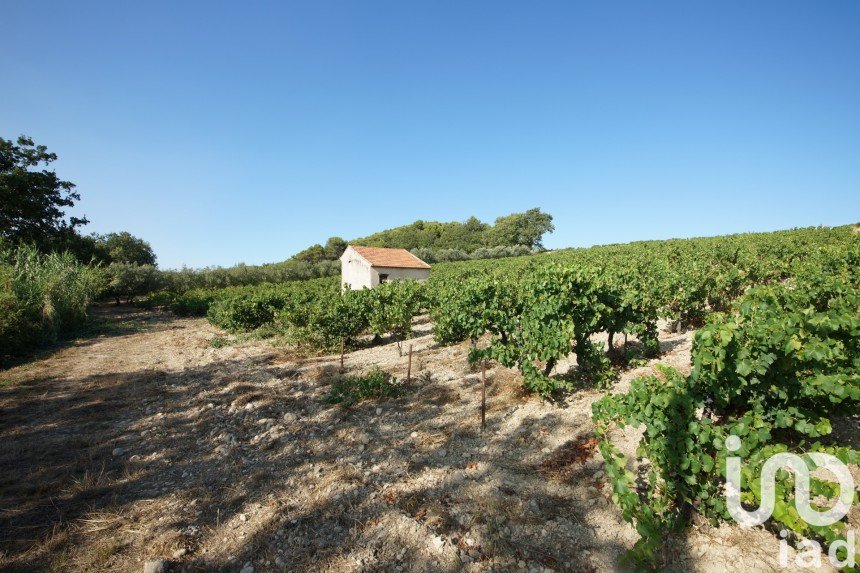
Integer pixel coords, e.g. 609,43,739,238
143,222,860,566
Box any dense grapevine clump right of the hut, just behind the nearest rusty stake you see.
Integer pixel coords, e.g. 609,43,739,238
432,264,657,396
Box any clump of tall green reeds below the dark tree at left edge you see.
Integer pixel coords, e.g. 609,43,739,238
0,242,104,362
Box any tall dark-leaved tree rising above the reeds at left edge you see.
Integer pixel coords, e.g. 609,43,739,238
0,135,89,251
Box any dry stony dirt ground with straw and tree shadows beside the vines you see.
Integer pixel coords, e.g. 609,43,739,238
0,309,832,573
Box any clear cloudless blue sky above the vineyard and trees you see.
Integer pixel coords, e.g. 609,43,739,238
0,1,860,267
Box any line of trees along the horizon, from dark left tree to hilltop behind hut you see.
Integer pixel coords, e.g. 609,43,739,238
0,136,553,304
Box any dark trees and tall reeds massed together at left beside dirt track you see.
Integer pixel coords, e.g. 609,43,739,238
0,136,163,324
